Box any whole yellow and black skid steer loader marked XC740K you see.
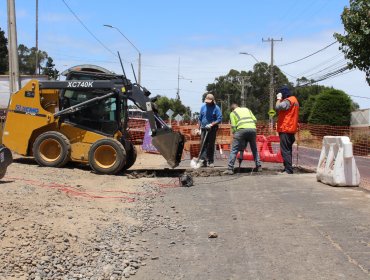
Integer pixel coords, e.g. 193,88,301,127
3,66,185,174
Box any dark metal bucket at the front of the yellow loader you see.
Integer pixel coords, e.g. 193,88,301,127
152,130,185,168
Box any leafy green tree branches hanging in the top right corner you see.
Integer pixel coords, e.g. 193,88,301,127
334,0,370,85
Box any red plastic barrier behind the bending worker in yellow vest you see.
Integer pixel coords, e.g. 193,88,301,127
237,135,283,163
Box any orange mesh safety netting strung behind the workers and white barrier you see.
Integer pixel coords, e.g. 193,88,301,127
161,122,370,189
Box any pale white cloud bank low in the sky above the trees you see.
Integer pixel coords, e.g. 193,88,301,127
48,31,370,111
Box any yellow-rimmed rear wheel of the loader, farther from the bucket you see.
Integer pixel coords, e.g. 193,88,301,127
32,131,71,167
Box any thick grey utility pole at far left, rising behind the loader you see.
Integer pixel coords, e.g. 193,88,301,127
7,0,20,95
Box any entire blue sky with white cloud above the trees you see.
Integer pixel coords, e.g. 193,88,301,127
0,0,370,112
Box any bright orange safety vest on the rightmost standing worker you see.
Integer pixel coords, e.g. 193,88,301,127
277,96,299,133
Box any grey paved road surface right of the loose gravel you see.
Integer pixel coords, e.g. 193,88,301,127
132,172,370,280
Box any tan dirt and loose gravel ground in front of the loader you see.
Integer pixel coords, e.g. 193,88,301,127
0,153,178,279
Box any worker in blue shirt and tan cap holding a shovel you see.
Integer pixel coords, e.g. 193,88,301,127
199,93,222,168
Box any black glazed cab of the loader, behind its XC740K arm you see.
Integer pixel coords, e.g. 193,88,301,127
59,66,127,136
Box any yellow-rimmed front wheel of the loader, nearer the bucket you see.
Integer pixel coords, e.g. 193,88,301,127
89,139,126,174
